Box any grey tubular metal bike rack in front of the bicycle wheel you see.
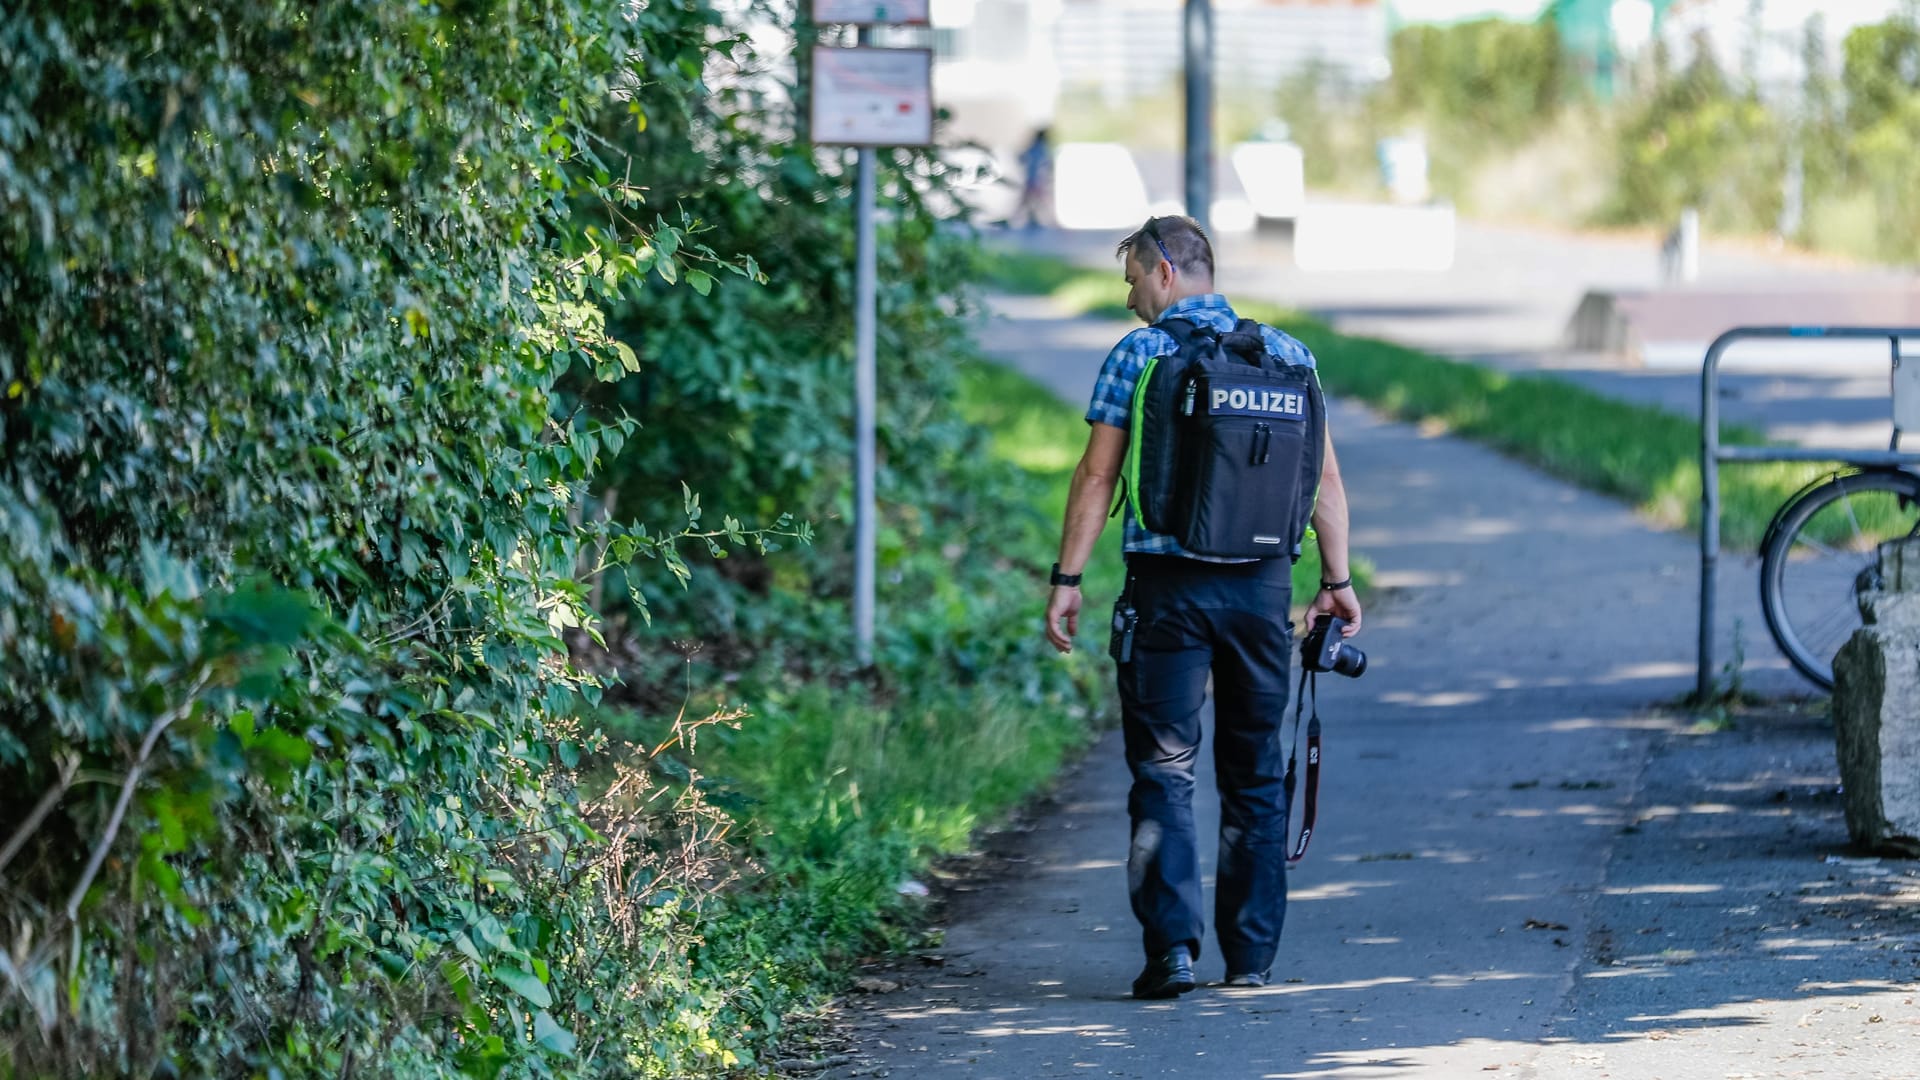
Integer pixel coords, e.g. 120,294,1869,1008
1693,327,1920,701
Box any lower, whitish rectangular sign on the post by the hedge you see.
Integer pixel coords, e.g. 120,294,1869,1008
812,46,933,146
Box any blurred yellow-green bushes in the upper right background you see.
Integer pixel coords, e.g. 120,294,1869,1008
1273,6,1920,261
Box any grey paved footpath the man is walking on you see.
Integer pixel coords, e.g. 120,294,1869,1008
828,300,1920,1080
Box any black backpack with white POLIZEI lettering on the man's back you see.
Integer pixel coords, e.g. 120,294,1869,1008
1125,319,1327,559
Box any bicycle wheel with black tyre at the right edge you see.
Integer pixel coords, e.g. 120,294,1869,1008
1761,469,1920,690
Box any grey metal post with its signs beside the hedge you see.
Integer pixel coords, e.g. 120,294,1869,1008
812,12,933,667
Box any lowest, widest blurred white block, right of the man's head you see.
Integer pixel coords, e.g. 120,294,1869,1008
1294,204,1453,271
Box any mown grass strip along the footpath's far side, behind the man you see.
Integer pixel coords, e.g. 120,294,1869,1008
993,245,1893,548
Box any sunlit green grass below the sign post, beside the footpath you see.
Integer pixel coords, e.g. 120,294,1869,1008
583,657,1106,1080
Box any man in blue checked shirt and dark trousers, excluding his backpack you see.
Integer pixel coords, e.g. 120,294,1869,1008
1046,217,1361,997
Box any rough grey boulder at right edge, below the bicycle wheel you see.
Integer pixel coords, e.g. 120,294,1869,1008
1834,538,1920,855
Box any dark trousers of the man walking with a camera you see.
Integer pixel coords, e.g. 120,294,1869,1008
1119,555,1292,972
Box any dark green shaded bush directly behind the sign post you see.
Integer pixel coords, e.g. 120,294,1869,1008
568,10,1066,687
